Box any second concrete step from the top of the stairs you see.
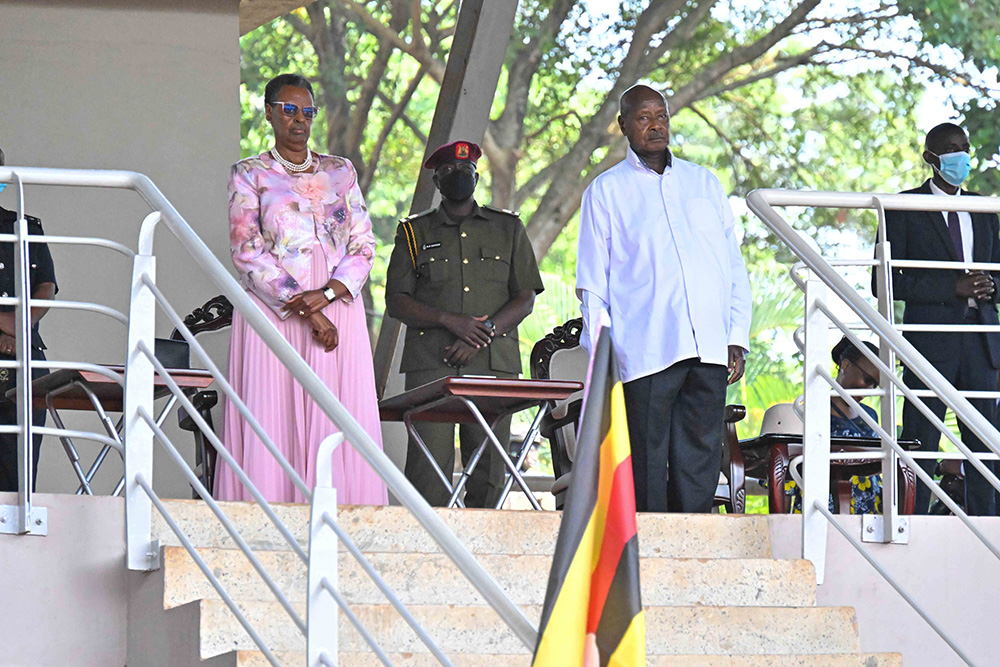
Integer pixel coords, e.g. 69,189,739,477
163,547,816,608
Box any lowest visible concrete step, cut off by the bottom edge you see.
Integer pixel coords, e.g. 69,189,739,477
234,651,903,667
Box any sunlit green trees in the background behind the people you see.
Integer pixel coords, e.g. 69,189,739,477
242,0,1000,456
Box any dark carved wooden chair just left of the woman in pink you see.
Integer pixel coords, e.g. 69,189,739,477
170,294,233,498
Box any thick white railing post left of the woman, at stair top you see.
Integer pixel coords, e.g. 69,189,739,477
123,243,160,570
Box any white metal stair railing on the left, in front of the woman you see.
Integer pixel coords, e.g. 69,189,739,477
0,167,537,665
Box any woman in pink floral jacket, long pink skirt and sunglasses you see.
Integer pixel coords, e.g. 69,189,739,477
215,74,387,505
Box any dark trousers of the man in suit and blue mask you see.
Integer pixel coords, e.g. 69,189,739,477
902,328,997,516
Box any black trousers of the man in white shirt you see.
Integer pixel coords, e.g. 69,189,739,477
624,359,728,513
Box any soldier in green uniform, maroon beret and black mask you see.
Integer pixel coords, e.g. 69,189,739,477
385,141,543,507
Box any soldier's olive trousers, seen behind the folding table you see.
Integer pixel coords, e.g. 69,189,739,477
404,366,517,507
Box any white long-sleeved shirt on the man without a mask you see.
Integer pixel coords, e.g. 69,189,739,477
576,148,751,382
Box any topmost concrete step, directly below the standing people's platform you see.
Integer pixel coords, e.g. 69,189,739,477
153,500,771,558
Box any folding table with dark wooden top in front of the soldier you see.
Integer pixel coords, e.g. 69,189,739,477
379,376,583,510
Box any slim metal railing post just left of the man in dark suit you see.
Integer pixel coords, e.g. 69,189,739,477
876,197,919,543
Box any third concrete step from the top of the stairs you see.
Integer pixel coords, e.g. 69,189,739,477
199,600,860,658
